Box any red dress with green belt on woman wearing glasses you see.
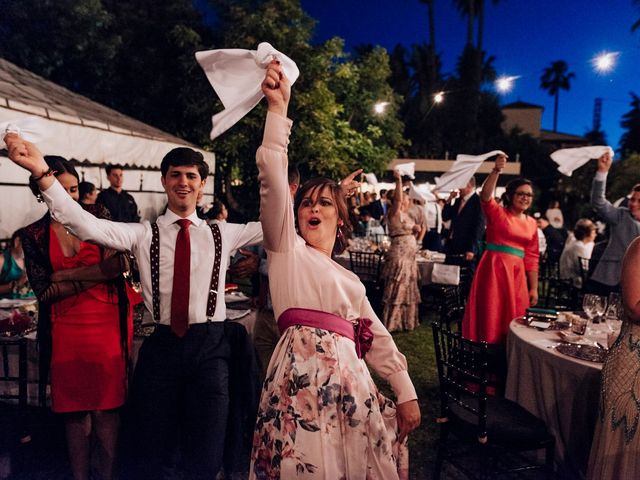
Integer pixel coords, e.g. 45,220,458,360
462,199,539,343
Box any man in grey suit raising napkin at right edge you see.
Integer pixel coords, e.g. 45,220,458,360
585,153,640,296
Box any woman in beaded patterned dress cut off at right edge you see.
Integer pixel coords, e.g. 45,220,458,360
587,238,640,480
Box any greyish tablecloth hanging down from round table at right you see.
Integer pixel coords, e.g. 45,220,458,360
505,319,602,478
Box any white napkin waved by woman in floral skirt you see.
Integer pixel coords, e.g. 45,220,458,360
196,42,300,140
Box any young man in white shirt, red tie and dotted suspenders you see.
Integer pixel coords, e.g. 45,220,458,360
5,134,262,479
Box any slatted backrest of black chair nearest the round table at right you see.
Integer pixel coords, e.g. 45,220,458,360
431,322,490,442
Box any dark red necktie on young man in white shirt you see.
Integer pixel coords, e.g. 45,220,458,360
171,218,191,337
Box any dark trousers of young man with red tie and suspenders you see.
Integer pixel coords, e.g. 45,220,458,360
131,322,231,480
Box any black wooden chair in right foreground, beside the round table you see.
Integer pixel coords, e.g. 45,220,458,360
432,323,555,479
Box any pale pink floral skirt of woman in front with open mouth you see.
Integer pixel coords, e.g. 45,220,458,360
249,325,409,480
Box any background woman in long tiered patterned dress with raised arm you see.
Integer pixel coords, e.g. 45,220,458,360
382,170,420,332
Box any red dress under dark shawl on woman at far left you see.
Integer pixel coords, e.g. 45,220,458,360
49,228,133,412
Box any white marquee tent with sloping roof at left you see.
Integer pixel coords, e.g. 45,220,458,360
0,58,215,239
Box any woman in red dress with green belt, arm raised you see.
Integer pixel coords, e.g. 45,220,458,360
462,155,539,344
